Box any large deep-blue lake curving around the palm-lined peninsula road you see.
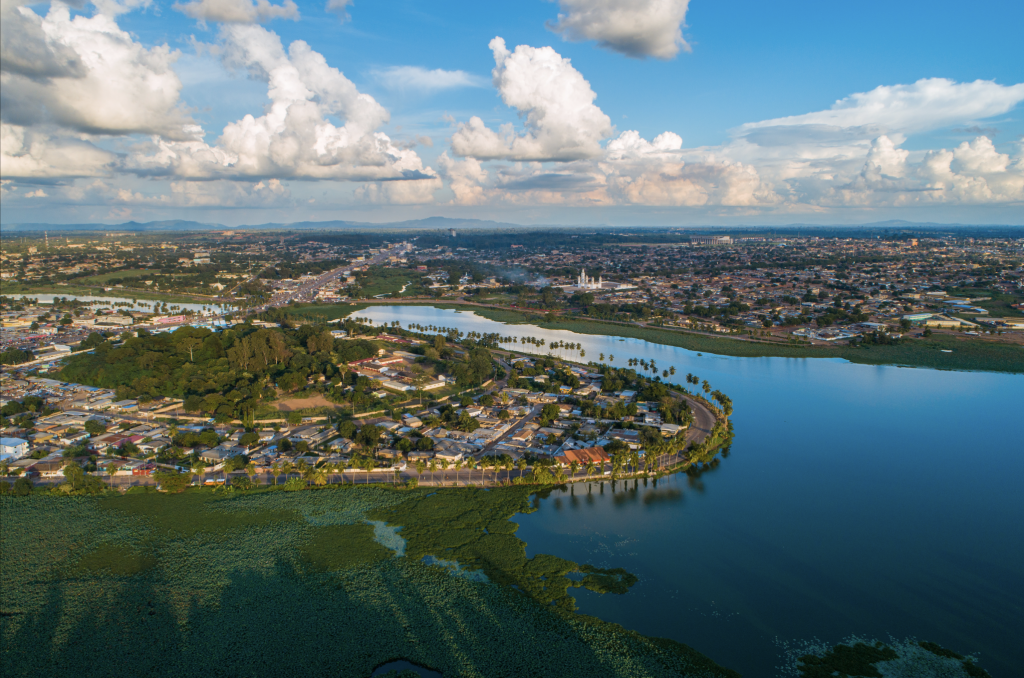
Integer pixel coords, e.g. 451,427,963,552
353,306,1024,677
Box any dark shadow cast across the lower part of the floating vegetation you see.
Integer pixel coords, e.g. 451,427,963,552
0,559,735,678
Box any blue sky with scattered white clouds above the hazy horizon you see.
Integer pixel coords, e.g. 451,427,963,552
0,0,1024,226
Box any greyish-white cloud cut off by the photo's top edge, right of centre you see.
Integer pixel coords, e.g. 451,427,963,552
550,0,690,59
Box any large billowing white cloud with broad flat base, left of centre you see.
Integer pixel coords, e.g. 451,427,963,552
128,25,434,186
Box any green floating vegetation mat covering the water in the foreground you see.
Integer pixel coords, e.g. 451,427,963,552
0,486,737,678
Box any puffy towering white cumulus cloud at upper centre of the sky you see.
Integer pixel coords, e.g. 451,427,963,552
452,38,613,161
